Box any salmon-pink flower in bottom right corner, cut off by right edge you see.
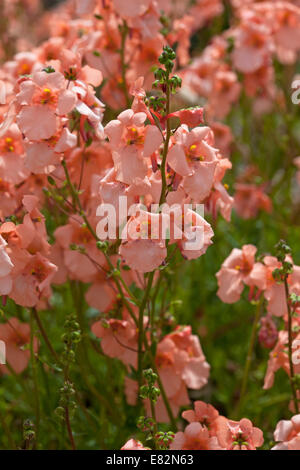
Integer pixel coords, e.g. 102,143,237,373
271,414,300,450
